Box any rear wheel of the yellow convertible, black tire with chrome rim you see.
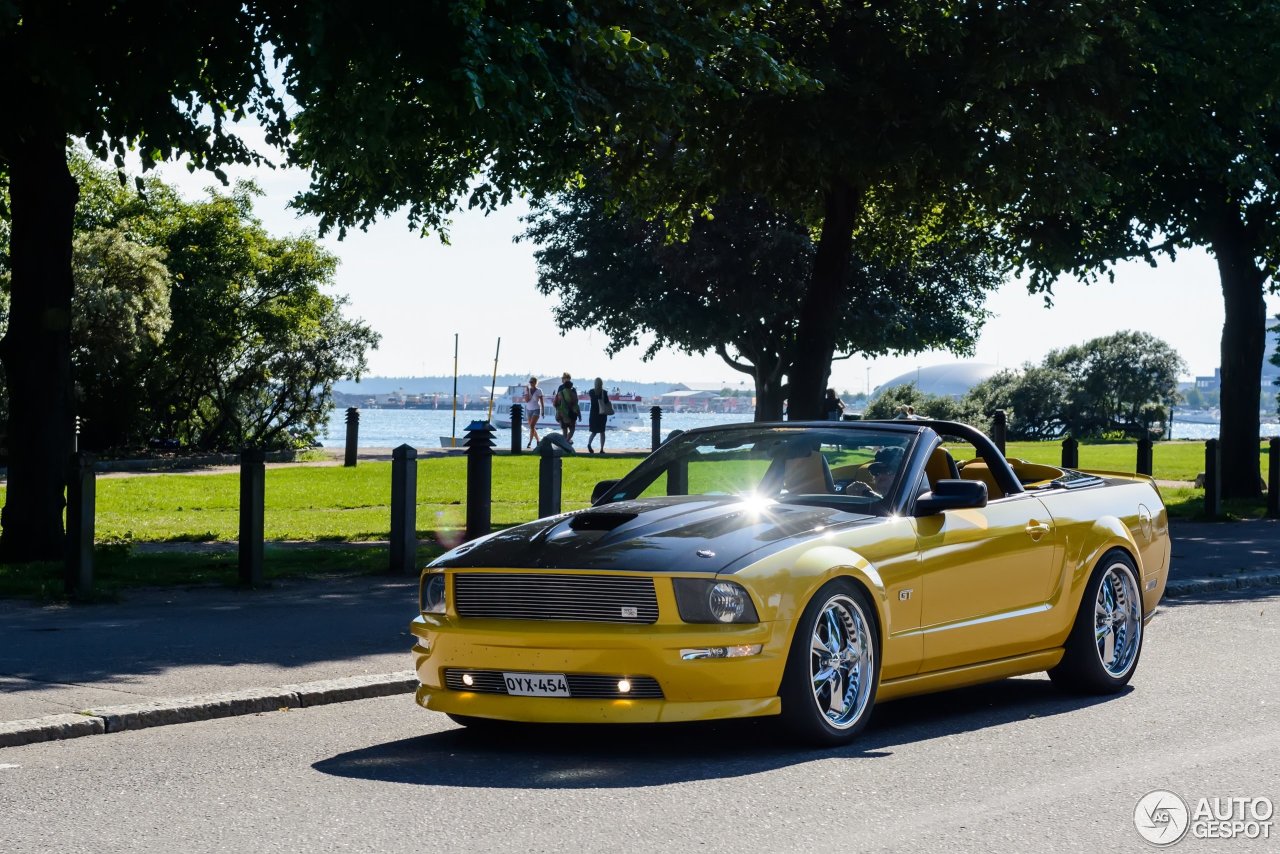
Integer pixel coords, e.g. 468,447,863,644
1048,551,1146,694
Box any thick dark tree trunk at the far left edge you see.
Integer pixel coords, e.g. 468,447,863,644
0,125,79,562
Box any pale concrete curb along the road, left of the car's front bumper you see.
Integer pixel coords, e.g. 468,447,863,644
0,671,417,748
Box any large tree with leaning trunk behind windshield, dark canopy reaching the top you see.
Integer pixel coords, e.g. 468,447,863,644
563,3,1131,417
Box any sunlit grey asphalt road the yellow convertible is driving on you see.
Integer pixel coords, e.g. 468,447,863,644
0,597,1280,854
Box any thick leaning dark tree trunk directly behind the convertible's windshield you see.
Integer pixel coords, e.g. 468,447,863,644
787,183,859,421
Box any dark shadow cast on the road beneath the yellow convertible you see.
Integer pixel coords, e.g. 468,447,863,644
312,677,1130,789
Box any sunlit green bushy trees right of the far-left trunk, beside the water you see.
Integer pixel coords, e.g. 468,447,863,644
0,156,378,451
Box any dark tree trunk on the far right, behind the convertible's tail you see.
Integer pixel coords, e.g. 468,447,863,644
1212,230,1267,498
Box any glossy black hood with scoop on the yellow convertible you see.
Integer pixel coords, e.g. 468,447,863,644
431,495,881,572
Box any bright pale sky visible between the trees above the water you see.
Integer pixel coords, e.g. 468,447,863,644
152,153,1280,393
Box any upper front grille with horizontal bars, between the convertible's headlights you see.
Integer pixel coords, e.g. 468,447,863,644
453,572,658,624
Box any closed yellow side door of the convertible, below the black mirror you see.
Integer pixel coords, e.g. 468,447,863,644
914,493,1059,673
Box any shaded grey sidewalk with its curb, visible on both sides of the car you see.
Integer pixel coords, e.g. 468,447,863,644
0,520,1280,748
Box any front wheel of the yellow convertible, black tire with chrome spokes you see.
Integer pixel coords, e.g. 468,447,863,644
778,579,881,746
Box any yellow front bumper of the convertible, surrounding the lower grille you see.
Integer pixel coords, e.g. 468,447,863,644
411,615,788,723
